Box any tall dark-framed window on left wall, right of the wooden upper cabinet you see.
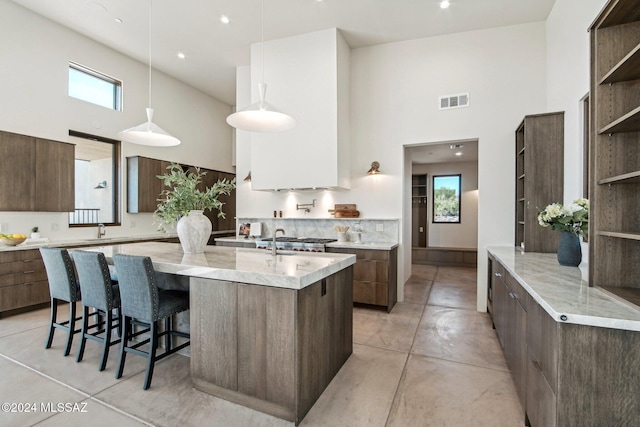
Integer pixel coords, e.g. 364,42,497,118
69,131,120,227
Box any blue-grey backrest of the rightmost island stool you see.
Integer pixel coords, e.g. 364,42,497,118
113,254,159,323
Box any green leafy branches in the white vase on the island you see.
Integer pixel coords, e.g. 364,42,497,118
153,163,236,231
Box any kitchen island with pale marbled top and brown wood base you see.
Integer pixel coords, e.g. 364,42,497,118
79,242,355,425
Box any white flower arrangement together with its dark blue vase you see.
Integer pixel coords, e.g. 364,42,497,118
538,198,589,267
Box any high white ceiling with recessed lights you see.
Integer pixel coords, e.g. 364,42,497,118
12,0,555,105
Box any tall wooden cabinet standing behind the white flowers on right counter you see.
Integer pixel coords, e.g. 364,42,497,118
515,112,564,252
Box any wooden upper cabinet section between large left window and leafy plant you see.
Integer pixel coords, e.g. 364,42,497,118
127,156,171,213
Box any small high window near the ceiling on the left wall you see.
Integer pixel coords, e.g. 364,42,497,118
69,62,122,111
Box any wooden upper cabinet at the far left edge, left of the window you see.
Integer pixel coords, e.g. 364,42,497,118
0,132,75,212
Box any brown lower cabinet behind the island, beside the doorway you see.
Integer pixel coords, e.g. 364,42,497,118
326,248,398,312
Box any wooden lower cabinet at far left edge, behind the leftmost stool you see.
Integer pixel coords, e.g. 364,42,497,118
0,249,49,312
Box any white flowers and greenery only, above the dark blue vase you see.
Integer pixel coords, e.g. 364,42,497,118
538,198,589,235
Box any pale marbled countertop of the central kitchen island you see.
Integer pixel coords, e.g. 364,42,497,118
76,242,356,289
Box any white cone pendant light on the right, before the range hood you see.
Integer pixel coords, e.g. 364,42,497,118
227,0,297,132
